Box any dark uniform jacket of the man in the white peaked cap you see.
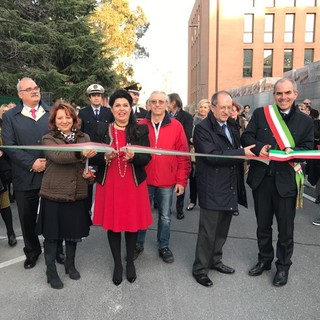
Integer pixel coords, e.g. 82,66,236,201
78,106,113,142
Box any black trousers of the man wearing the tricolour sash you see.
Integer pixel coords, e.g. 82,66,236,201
252,176,296,271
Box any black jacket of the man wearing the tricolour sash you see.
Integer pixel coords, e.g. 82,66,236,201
241,106,314,197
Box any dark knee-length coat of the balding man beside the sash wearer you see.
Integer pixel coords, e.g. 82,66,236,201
193,112,247,211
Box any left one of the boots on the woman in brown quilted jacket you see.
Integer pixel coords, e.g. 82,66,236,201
44,239,63,289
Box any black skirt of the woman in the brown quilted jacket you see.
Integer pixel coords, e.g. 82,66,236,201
36,198,92,240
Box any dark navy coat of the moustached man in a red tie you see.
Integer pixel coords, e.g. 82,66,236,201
2,103,50,191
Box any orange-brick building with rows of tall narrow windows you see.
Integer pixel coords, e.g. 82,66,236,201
188,0,320,105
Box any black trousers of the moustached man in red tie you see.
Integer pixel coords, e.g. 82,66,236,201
15,189,41,258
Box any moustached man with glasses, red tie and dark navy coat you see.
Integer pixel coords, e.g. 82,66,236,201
2,78,49,269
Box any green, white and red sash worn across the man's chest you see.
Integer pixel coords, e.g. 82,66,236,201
263,103,304,208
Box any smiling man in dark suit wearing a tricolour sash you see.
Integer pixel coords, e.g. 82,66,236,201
241,78,313,287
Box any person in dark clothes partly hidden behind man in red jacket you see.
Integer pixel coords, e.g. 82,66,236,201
168,93,193,220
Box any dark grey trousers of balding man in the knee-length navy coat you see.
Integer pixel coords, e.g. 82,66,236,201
192,208,233,274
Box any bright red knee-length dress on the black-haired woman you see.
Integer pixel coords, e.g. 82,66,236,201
93,129,152,232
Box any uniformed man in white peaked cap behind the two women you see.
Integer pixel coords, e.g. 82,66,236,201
78,84,113,213
